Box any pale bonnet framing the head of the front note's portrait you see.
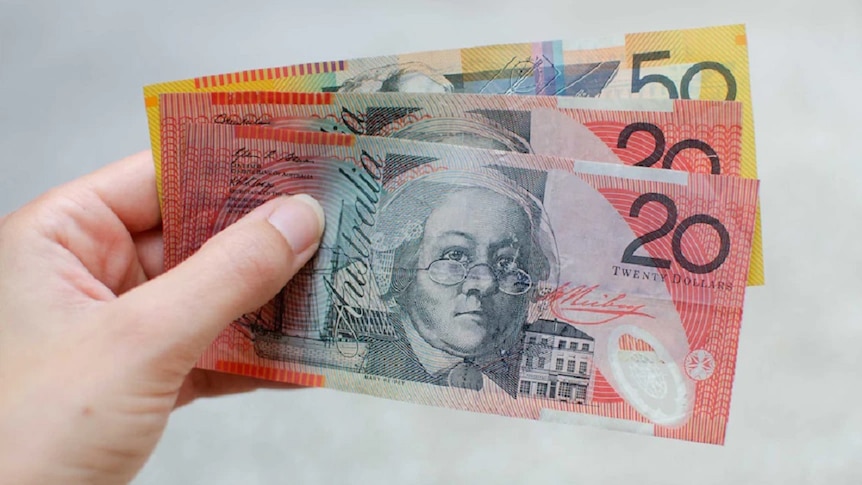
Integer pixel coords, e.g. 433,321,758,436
371,168,559,306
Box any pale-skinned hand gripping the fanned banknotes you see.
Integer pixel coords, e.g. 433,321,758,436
0,152,323,484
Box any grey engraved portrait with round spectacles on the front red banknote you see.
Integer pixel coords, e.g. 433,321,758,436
366,171,556,396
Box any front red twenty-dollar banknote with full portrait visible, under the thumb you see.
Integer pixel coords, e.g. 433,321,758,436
182,124,758,444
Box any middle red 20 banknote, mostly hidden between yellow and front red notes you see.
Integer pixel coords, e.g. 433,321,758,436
160,92,741,267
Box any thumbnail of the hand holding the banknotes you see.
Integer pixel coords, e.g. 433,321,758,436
267,194,325,254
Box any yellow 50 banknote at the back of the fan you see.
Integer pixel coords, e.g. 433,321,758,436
144,25,764,285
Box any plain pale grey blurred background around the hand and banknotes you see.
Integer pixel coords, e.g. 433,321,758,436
0,0,862,485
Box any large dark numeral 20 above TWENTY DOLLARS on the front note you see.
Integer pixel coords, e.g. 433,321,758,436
622,192,730,274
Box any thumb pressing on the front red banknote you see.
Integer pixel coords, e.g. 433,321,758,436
116,194,324,367
